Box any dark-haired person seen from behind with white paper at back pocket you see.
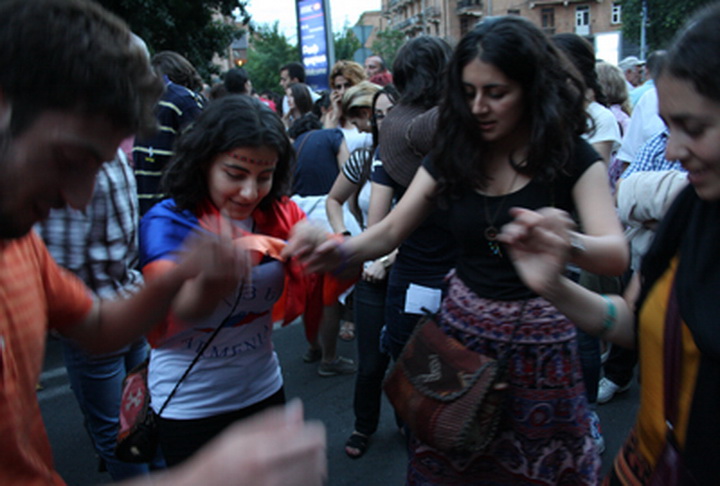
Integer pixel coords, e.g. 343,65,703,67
370,36,458,357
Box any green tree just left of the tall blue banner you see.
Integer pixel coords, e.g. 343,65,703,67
244,22,300,95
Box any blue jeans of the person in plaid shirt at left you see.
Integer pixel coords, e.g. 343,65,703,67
63,339,164,481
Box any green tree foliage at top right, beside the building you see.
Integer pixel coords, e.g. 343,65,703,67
622,0,715,51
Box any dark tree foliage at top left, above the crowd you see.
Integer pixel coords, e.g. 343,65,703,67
97,0,250,79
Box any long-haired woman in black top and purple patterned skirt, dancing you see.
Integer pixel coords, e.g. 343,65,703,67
290,16,628,485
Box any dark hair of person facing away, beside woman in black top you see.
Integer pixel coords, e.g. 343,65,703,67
393,35,452,109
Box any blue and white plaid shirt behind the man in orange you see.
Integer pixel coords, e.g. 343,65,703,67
36,151,143,299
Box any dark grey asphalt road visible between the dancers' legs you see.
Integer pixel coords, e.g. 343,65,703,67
38,324,638,486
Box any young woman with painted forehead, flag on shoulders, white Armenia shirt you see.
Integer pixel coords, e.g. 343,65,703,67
140,95,338,465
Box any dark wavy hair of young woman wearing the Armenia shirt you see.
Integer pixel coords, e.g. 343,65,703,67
161,95,294,211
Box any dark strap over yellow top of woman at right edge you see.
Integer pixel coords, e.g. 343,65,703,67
663,282,683,430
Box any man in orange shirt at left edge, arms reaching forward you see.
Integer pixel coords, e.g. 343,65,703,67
0,0,325,485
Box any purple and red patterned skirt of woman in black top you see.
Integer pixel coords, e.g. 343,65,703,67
407,275,600,486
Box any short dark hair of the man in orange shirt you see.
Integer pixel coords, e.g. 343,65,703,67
0,0,164,135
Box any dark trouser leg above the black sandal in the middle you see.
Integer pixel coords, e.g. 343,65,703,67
353,280,390,436
